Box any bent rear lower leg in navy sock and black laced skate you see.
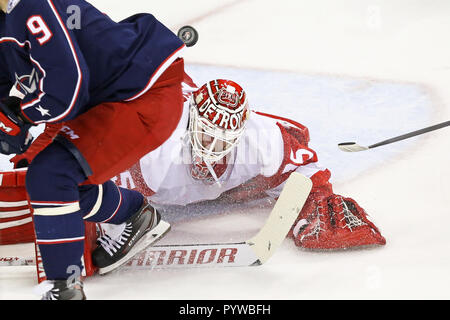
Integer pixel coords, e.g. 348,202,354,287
80,181,170,274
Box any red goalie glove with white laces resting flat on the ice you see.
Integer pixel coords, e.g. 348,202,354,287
290,172,386,249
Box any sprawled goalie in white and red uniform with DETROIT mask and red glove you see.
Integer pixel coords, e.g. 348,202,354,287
0,75,386,278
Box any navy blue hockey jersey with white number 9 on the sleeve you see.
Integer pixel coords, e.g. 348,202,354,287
0,0,185,124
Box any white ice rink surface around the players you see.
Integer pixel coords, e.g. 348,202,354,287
0,0,450,300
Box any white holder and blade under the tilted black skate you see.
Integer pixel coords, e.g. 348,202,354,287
98,220,170,275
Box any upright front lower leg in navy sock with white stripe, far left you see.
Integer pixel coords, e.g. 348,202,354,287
26,142,86,299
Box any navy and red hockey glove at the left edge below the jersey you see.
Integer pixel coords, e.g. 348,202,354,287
0,97,33,155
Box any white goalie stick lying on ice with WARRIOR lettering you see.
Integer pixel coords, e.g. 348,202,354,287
0,172,312,270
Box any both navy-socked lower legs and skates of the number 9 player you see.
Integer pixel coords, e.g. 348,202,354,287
26,142,169,299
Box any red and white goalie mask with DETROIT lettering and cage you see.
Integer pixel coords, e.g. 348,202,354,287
189,79,249,182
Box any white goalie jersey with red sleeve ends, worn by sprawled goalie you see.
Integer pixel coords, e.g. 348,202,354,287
114,94,321,205
